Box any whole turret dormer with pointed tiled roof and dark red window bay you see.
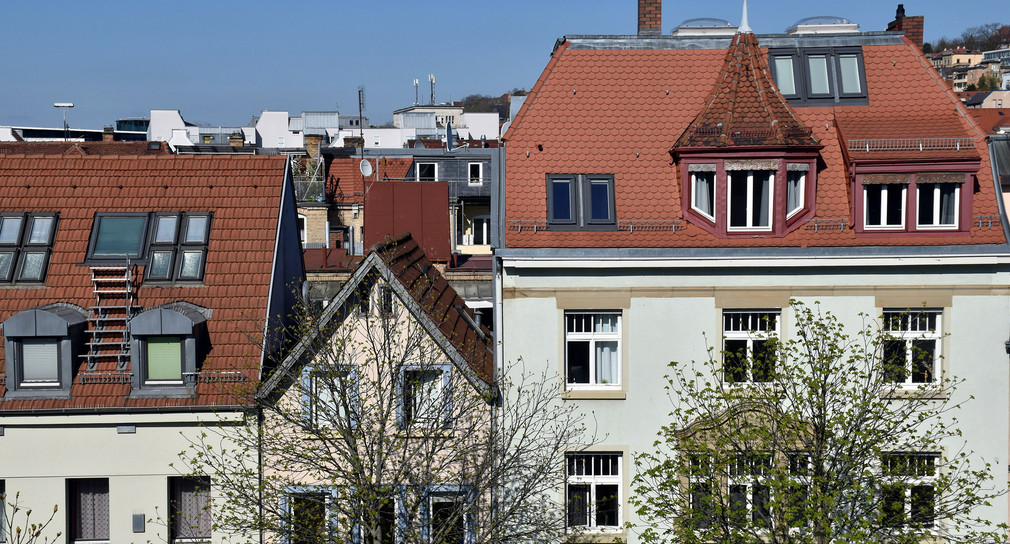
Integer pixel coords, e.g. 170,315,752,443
670,23,821,237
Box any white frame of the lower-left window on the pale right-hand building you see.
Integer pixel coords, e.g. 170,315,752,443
565,451,624,532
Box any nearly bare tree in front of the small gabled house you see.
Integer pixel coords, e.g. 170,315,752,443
182,277,588,544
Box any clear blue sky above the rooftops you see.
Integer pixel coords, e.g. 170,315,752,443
0,0,1010,128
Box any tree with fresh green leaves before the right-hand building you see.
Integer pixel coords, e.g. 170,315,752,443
631,301,1006,544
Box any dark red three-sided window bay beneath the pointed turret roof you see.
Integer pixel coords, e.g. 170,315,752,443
682,154,815,236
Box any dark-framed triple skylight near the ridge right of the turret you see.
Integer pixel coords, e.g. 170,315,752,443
768,47,869,106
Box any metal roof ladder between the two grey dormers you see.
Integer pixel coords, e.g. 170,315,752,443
84,264,139,370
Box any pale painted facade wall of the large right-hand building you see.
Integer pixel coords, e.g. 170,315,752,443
500,259,1010,543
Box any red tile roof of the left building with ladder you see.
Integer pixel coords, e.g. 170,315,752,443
0,155,285,411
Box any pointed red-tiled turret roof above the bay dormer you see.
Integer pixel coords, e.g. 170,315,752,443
674,32,817,149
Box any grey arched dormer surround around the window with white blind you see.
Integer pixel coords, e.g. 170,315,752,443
0,303,87,399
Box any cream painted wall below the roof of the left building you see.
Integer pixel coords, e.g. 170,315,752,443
0,413,250,543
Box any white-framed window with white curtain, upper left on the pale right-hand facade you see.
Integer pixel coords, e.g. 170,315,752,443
565,312,621,389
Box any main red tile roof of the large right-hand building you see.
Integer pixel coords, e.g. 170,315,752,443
502,38,1005,247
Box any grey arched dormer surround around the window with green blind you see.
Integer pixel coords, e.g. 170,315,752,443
127,303,210,397
